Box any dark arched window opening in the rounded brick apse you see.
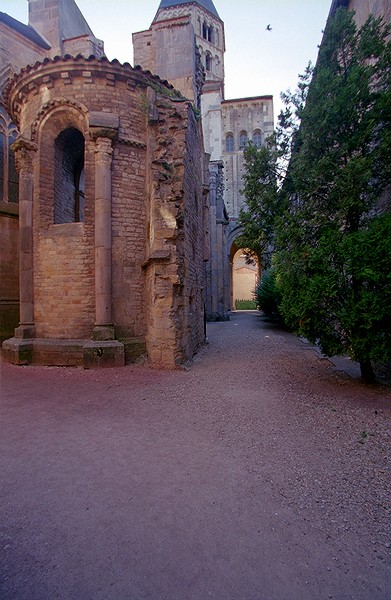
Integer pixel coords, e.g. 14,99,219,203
54,127,84,224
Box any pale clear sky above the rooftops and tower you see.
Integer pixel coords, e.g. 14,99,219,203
0,0,331,123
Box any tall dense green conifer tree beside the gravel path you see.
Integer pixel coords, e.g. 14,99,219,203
242,9,391,381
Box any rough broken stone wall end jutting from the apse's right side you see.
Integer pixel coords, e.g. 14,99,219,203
145,91,205,368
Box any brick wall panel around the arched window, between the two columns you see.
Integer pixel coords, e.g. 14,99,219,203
33,101,95,339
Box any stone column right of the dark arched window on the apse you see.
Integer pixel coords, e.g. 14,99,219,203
93,130,117,340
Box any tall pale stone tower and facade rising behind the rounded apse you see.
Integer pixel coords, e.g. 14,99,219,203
133,0,273,320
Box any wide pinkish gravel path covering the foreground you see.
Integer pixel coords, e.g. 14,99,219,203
0,313,391,600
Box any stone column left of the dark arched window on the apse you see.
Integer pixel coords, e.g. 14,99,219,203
12,137,37,339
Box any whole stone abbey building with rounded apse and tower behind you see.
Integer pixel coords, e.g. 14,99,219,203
0,0,273,368
